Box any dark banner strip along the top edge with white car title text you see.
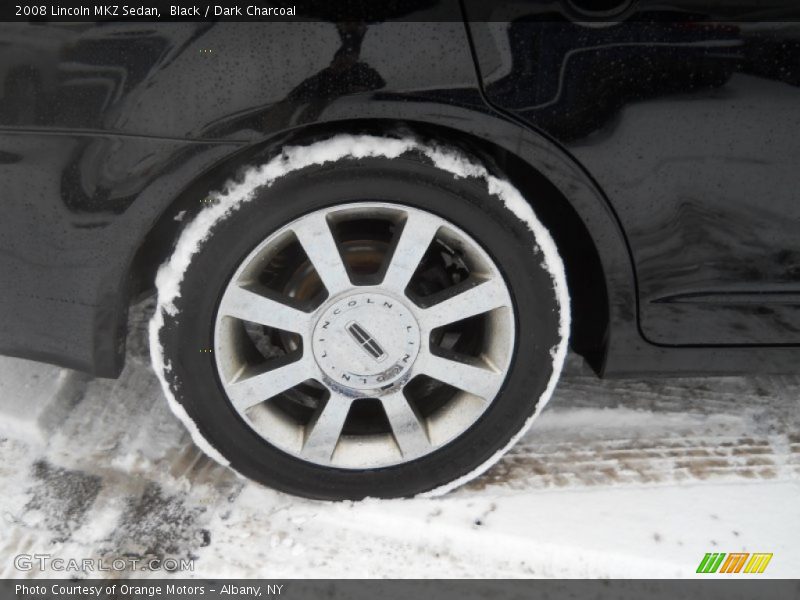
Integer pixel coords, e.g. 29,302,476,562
0,0,800,24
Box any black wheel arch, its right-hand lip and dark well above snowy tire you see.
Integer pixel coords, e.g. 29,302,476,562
125,115,636,372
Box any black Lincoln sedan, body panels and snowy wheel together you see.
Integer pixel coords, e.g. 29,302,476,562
0,0,800,499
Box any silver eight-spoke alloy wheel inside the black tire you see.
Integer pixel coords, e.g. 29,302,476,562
214,202,515,469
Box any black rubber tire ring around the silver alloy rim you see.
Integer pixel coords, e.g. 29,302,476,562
157,143,564,499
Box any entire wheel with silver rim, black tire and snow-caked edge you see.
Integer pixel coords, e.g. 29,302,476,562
150,135,569,499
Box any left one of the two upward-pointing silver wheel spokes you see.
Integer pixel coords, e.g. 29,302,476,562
292,213,351,296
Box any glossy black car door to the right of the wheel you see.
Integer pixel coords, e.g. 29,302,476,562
465,0,800,345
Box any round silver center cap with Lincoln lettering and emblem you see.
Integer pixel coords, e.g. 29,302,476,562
311,293,420,390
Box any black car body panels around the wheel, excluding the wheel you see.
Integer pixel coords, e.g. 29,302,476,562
0,0,800,377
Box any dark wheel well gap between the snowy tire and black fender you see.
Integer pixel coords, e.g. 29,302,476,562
131,121,609,372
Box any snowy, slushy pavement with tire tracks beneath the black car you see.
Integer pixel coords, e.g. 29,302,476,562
0,303,800,578
